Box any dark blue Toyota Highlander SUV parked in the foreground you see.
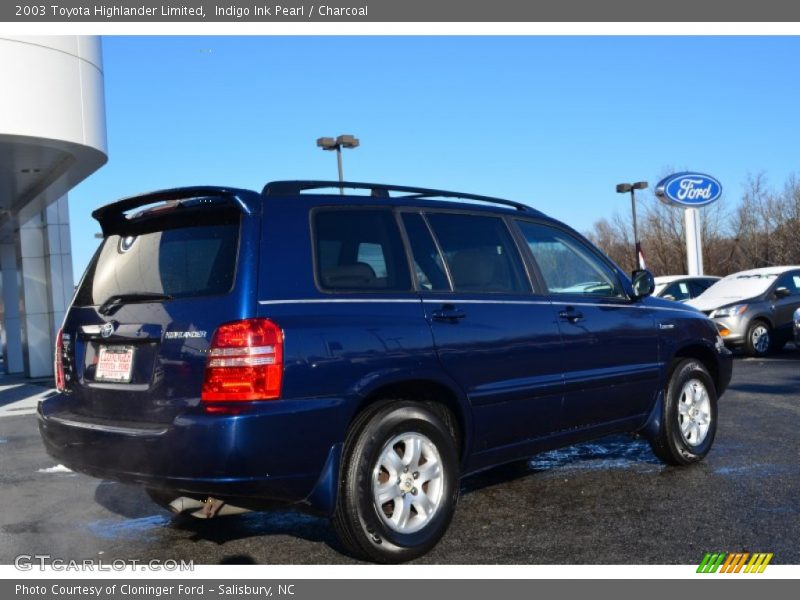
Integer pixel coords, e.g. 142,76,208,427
39,181,731,562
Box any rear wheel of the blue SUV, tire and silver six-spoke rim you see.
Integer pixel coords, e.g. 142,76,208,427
332,400,459,563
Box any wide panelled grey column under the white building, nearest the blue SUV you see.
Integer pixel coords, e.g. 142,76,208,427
18,196,73,377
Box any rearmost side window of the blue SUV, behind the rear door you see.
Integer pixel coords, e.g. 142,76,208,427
313,208,411,292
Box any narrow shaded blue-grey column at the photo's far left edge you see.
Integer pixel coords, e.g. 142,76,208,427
0,240,25,373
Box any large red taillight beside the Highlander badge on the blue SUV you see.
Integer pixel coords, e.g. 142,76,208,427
200,319,283,402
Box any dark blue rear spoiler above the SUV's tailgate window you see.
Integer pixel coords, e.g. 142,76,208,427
92,186,258,237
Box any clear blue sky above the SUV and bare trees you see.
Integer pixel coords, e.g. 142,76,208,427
70,36,800,279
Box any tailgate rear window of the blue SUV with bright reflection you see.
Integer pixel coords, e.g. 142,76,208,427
75,219,239,306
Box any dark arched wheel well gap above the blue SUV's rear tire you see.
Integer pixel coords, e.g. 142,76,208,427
353,380,466,459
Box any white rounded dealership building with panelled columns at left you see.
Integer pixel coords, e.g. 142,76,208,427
0,35,107,377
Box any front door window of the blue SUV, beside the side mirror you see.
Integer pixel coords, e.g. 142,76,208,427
518,221,625,297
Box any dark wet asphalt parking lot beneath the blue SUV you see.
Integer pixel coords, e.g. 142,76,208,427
0,345,800,564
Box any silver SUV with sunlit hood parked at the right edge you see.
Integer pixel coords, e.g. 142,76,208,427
686,266,800,356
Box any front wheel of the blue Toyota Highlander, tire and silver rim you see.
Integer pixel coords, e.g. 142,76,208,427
650,359,717,466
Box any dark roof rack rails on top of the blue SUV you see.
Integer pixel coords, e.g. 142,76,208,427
261,181,538,213
